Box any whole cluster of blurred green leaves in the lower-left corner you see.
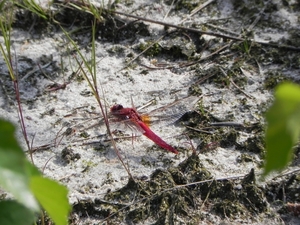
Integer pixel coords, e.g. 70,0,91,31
0,119,70,225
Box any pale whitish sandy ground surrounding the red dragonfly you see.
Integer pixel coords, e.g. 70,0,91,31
0,0,300,224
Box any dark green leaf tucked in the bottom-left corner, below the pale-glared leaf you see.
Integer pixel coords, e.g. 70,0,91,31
0,200,36,225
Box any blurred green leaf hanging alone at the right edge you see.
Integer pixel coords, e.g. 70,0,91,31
264,83,300,175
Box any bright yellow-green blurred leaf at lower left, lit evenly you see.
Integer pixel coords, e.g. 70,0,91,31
30,176,71,225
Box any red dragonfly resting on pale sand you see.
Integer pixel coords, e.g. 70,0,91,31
110,96,196,154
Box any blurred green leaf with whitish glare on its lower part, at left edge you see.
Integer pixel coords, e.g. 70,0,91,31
0,119,39,211
